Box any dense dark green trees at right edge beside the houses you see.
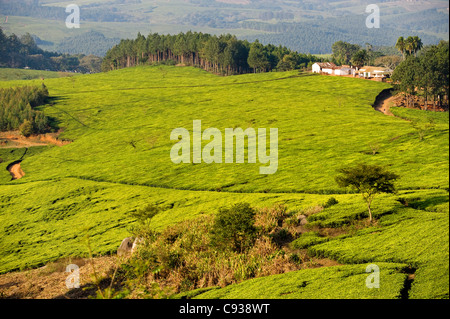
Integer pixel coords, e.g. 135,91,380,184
392,38,449,110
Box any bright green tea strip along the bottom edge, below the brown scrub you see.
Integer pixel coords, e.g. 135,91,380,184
191,263,406,299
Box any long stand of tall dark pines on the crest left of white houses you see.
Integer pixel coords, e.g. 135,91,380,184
102,31,321,75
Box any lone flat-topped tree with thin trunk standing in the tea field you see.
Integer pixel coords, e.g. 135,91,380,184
335,164,399,222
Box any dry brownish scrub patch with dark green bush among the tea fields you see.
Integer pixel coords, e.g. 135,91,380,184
112,203,314,297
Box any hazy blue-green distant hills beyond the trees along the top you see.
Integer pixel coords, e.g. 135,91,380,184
0,0,449,55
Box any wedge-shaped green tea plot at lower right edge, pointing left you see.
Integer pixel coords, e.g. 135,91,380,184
311,210,449,298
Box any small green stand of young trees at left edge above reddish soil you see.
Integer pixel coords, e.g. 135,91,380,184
0,84,50,136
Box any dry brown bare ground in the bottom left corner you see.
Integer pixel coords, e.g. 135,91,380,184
0,256,117,299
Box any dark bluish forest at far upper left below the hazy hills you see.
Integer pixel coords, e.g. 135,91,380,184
0,28,101,73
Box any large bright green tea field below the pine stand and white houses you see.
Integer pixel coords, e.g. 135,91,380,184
0,68,448,193
